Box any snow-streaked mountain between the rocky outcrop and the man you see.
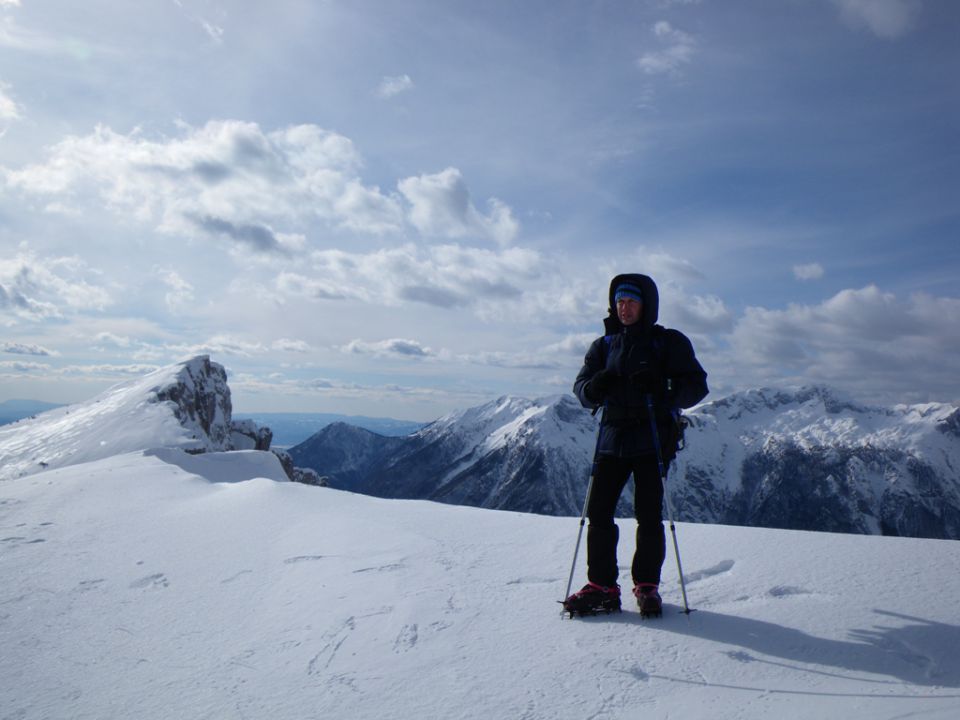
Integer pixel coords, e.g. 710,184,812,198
290,395,596,514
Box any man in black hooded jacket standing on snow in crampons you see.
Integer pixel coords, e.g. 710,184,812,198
563,274,708,616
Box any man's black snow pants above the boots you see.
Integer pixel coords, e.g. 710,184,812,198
587,453,666,587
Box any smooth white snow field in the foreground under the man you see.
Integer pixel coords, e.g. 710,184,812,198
0,450,960,720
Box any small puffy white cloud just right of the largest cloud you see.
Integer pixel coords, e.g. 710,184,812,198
398,168,519,245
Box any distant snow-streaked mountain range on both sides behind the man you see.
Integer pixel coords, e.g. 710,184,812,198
290,386,960,539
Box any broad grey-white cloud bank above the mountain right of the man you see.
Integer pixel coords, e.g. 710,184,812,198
729,285,960,400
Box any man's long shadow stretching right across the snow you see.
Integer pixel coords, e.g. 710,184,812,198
620,606,960,697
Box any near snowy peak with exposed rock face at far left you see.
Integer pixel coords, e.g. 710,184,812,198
0,355,270,480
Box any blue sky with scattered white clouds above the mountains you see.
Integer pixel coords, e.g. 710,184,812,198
0,0,960,420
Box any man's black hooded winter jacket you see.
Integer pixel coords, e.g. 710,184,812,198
573,274,709,457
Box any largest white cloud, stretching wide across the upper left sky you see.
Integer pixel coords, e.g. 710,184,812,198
4,120,404,253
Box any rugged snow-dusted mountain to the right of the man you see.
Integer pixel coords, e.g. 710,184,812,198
673,386,960,539
